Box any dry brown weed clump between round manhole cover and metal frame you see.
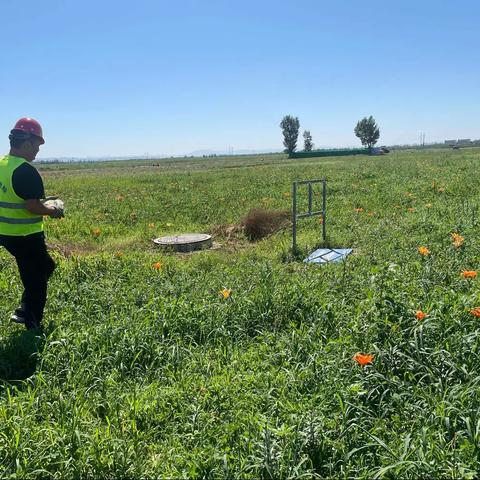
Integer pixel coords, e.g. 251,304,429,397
241,208,290,241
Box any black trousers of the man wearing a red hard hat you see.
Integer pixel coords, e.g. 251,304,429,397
0,232,55,323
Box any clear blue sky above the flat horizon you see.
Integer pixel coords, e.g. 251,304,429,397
0,0,480,157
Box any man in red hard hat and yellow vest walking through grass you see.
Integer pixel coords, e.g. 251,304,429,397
0,118,63,330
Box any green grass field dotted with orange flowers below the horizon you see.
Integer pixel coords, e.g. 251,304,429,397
0,149,480,478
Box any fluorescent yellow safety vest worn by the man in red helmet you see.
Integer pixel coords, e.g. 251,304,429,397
0,155,43,237
